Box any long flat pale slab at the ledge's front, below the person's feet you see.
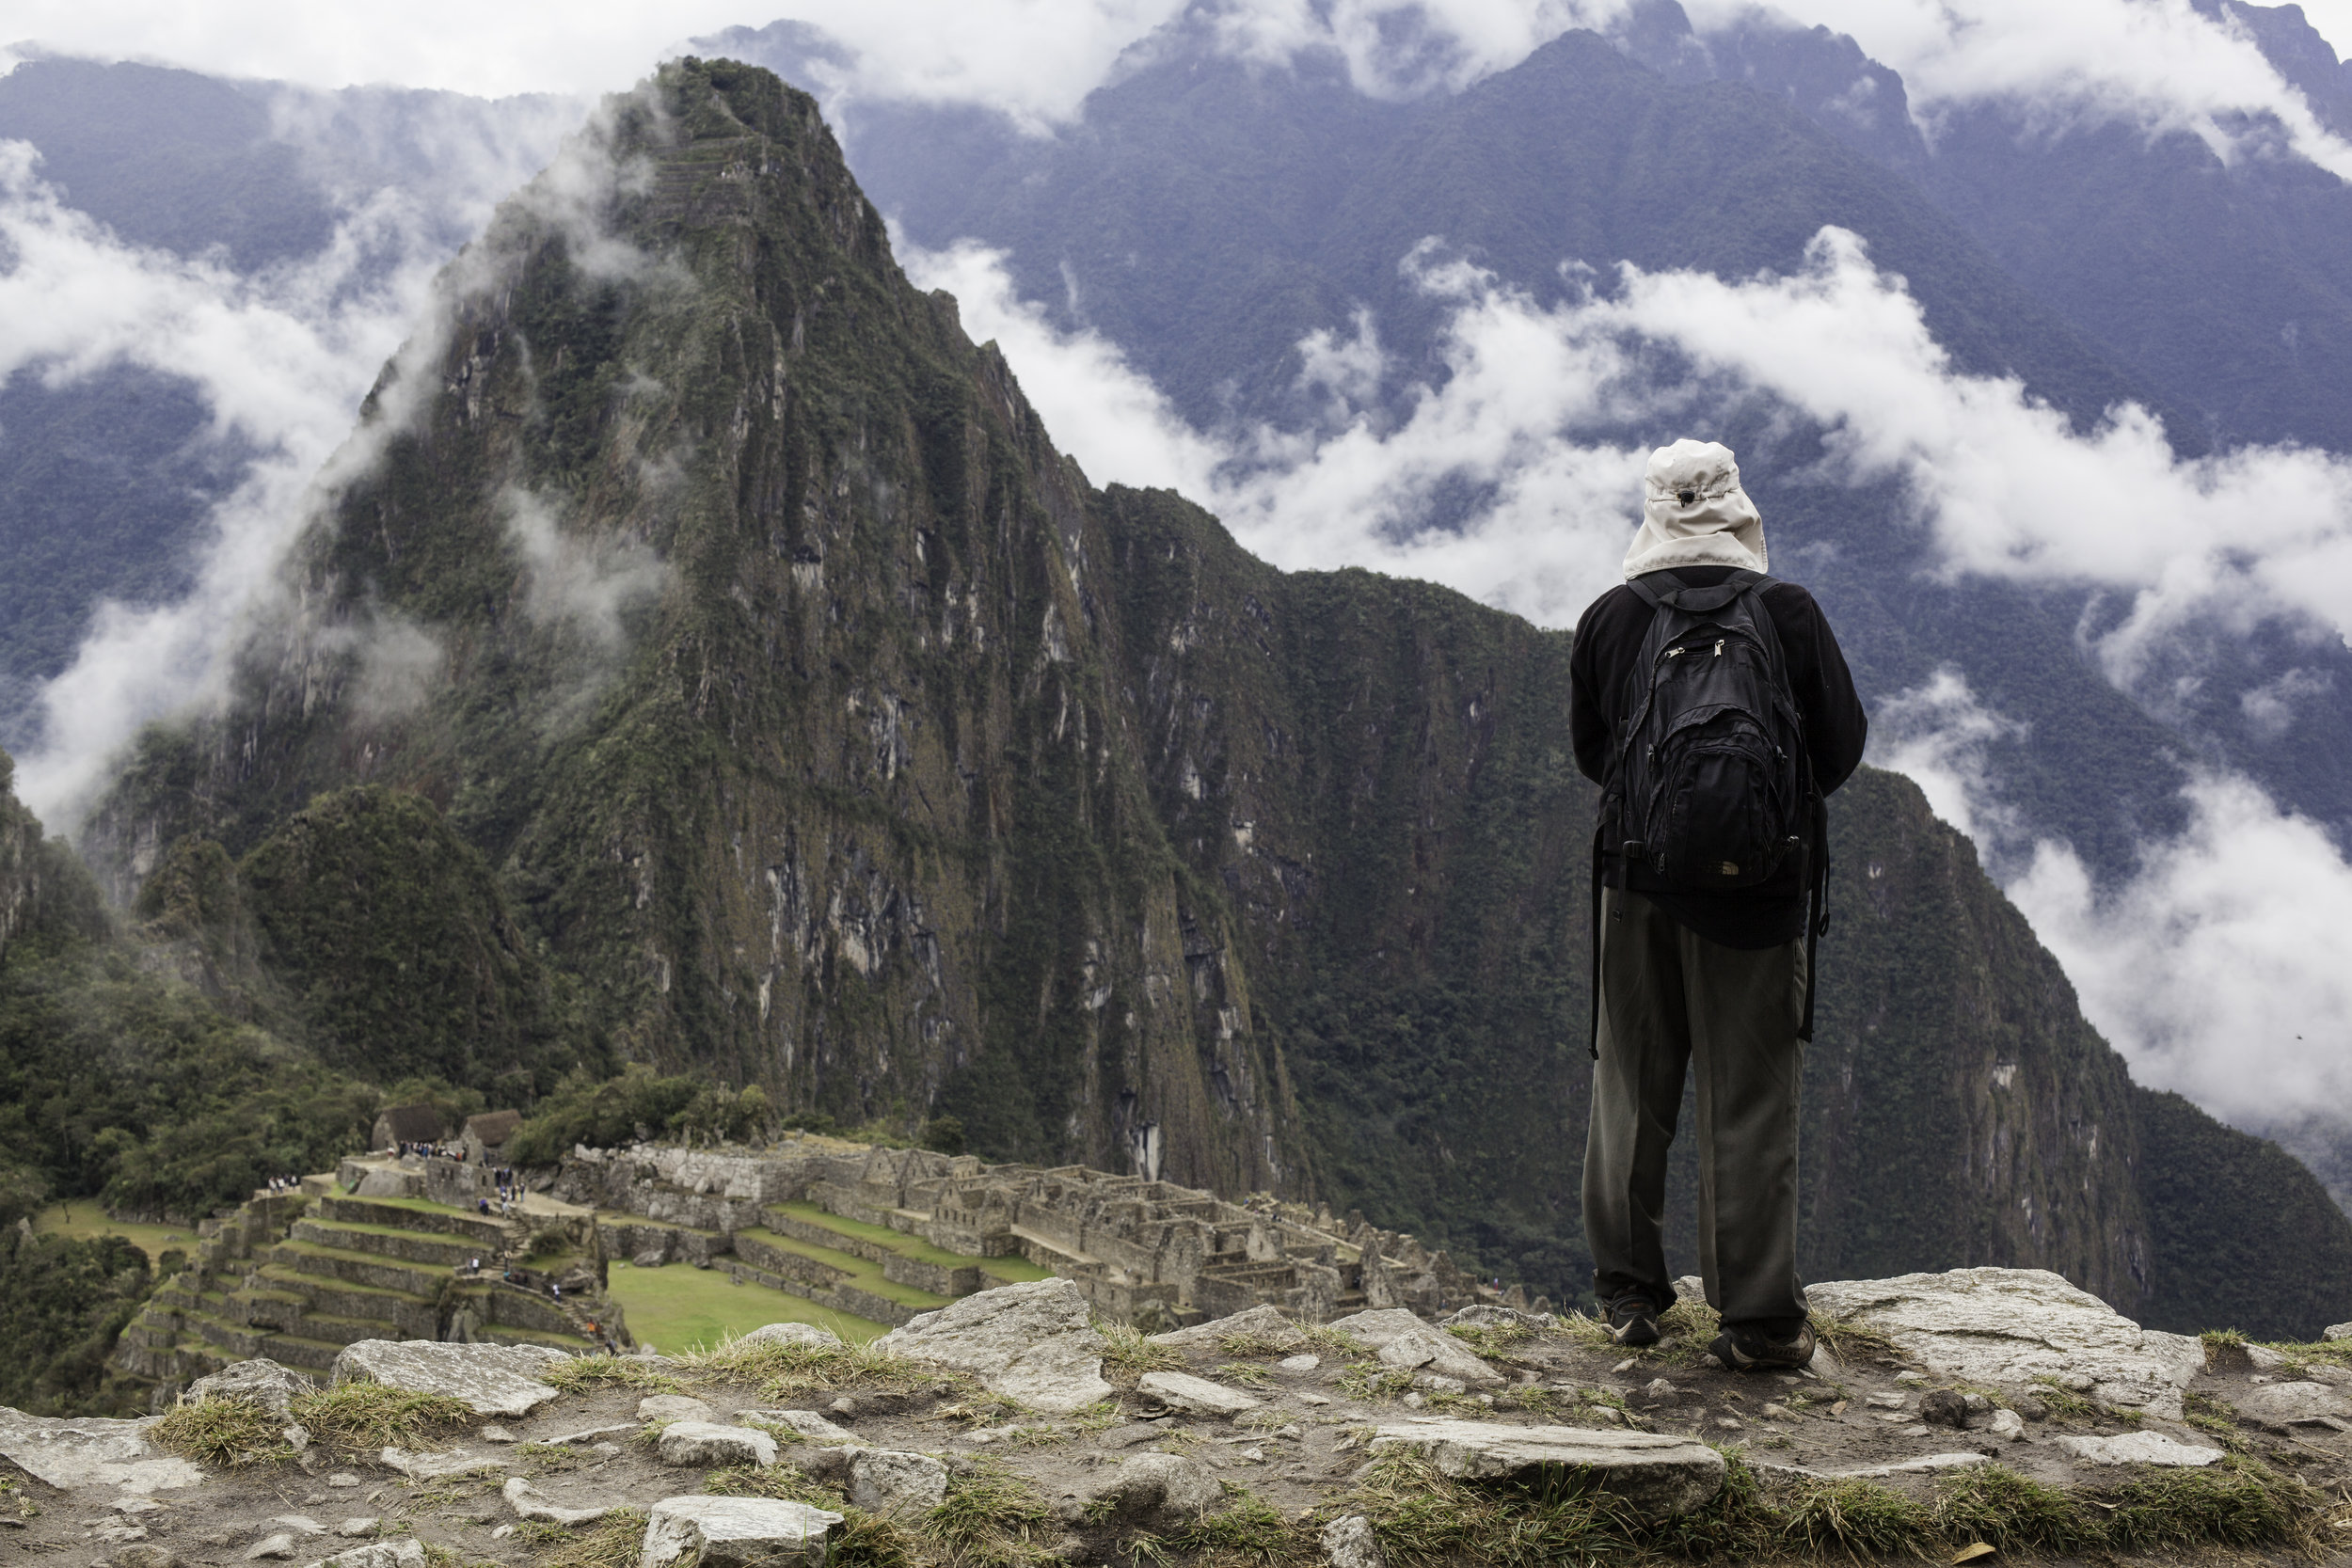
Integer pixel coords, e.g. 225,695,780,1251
1372,1420,1724,1519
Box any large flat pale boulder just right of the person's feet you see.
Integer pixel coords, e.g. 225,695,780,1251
1806,1270,2204,1420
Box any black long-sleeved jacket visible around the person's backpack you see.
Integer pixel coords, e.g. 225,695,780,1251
1569,566,1870,947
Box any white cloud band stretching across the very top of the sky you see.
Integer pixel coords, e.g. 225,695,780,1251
18,0,2352,174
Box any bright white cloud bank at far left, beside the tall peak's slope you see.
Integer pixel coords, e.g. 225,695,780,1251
0,99,577,832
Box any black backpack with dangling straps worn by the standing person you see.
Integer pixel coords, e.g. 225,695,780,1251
1593,571,1830,1055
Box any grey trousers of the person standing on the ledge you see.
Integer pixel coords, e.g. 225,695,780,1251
1585,889,1806,1333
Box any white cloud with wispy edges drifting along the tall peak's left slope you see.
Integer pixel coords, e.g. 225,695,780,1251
0,84,657,832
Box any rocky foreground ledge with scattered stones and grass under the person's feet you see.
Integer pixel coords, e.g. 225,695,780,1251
0,1270,2352,1568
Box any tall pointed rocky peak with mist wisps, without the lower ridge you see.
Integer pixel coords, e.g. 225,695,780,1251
92,63,1303,1190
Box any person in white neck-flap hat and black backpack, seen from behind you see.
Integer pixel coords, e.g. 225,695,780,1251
1569,439,1867,1370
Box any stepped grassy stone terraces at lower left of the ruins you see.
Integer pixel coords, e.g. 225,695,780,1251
116,1176,628,1385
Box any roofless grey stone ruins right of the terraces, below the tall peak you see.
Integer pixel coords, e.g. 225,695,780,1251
553,1138,1550,1328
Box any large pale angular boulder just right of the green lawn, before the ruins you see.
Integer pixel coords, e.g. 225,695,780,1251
875,1276,1113,1416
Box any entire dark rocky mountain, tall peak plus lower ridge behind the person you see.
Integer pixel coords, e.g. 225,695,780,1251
73,61,2352,1331
